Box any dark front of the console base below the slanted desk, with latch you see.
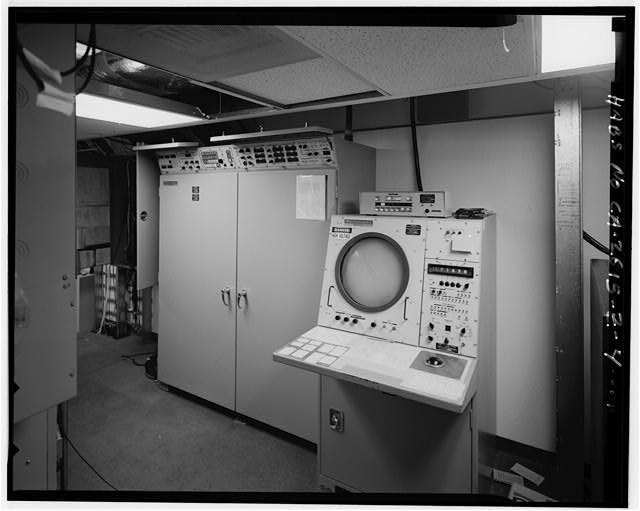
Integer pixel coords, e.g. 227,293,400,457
318,376,473,493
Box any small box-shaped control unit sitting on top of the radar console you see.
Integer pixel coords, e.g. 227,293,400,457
360,191,451,218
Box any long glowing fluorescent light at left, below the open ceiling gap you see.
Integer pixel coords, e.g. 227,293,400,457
76,93,202,128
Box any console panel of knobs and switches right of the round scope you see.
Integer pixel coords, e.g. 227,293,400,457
420,219,482,357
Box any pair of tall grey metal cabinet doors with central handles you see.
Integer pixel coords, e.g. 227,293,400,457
158,169,336,442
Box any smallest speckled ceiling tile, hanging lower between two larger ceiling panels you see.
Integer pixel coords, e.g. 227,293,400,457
220,58,372,105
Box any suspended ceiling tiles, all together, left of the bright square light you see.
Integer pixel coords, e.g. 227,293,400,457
79,17,535,105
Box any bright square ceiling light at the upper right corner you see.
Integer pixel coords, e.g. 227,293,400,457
541,15,616,73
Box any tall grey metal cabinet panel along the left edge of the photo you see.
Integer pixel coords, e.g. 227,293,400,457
13,23,77,422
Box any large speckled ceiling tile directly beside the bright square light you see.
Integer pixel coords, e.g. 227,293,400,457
281,17,535,96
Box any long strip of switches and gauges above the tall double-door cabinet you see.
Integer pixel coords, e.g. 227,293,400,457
157,136,337,174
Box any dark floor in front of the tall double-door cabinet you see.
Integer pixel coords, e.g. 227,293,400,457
67,334,317,492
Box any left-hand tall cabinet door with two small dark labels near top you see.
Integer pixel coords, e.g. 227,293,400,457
158,174,237,409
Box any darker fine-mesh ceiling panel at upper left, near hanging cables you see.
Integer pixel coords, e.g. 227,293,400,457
78,24,318,83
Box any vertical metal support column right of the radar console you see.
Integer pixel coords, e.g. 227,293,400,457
554,78,584,502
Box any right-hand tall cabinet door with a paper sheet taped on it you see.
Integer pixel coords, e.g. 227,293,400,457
236,170,335,442
